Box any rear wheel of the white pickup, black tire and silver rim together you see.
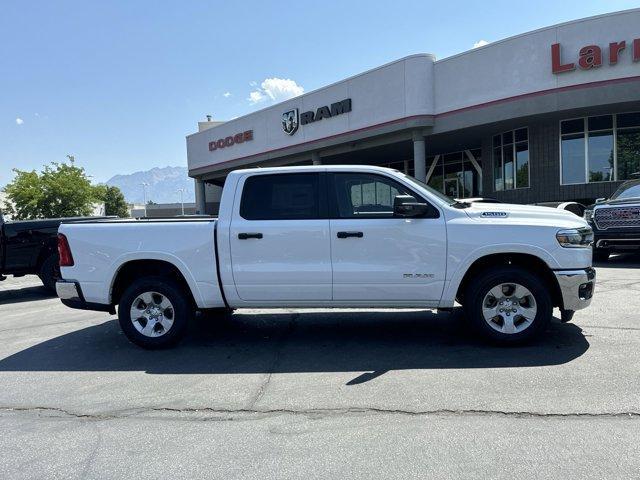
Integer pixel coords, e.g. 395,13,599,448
118,277,193,349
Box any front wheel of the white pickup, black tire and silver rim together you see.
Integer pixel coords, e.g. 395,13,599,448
464,266,553,345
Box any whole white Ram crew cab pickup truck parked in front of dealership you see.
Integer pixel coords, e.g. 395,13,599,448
57,165,595,348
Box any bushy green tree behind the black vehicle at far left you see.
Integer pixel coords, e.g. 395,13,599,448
3,158,97,220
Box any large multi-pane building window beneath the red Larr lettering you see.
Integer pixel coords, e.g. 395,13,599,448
560,112,640,185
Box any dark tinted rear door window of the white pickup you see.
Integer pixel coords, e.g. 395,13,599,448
240,173,320,220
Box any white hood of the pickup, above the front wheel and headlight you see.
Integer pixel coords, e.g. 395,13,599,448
464,203,588,228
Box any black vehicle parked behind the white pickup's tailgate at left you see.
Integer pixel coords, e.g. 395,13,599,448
0,213,102,292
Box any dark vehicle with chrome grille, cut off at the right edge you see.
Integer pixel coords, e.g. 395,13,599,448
584,174,640,262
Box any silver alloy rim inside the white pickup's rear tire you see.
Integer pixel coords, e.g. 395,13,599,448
130,292,174,337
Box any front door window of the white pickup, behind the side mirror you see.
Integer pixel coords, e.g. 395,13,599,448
332,173,420,218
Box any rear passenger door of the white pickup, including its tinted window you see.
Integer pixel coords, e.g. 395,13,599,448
230,172,331,302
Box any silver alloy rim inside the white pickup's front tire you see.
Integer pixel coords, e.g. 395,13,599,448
482,283,538,335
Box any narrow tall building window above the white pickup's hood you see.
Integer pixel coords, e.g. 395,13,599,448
493,127,529,192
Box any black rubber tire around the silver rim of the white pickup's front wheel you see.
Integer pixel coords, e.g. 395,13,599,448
464,266,553,345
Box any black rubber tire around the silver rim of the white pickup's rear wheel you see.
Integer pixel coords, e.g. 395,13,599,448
118,276,194,350
